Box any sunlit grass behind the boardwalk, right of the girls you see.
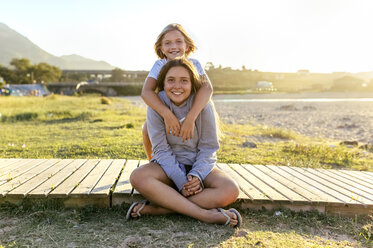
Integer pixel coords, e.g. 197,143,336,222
218,124,373,171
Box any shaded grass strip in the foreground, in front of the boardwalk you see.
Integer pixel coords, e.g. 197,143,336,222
0,204,373,248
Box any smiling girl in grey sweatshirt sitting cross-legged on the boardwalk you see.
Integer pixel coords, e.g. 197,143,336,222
126,59,242,227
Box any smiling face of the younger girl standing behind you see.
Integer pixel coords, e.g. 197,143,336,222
161,30,188,60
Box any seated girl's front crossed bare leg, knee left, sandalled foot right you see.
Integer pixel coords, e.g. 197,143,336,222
130,163,237,226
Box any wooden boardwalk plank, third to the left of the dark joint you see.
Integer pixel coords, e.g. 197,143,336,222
49,159,100,198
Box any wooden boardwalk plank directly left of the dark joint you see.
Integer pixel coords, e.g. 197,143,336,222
91,159,126,197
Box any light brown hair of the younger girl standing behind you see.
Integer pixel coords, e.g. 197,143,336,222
154,23,197,59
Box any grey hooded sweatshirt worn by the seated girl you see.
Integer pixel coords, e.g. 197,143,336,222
146,91,219,191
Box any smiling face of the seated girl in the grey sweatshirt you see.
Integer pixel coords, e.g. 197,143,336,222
163,66,192,106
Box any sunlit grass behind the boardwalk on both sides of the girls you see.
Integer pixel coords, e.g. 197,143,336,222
0,95,373,171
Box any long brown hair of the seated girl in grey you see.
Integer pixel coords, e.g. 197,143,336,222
155,58,202,93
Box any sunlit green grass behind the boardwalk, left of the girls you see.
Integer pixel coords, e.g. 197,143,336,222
0,96,145,158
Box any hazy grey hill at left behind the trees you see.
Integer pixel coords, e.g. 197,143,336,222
0,23,115,70
